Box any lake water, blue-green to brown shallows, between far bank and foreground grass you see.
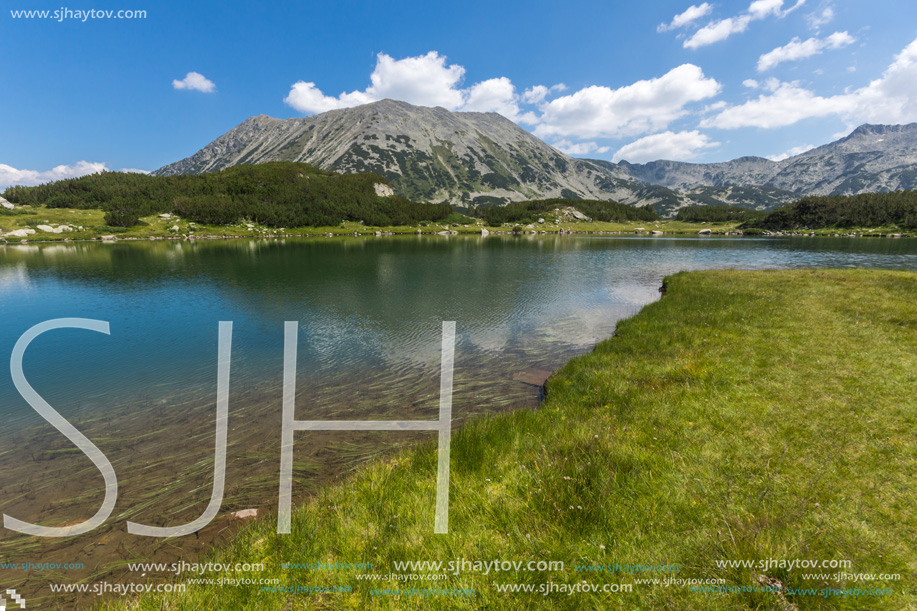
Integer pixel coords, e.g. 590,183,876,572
0,235,917,604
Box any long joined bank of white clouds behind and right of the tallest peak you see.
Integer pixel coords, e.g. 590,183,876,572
284,51,724,155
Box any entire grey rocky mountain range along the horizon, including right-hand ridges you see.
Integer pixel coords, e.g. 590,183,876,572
154,100,917,214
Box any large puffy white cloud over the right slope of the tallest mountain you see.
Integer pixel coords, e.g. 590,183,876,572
535,64,720,138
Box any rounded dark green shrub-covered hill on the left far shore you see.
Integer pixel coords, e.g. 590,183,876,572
3,162,452,227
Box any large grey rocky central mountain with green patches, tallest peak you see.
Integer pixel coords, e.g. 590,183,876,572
155,100,667,205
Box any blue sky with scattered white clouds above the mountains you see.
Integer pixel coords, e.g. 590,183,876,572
0,0,917,187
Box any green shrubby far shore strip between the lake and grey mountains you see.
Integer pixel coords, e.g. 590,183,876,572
0,169,917,242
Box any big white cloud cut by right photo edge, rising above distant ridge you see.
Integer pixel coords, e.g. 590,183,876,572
700,40,917,129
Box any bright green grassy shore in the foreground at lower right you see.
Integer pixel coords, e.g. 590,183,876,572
95,270,917,610
